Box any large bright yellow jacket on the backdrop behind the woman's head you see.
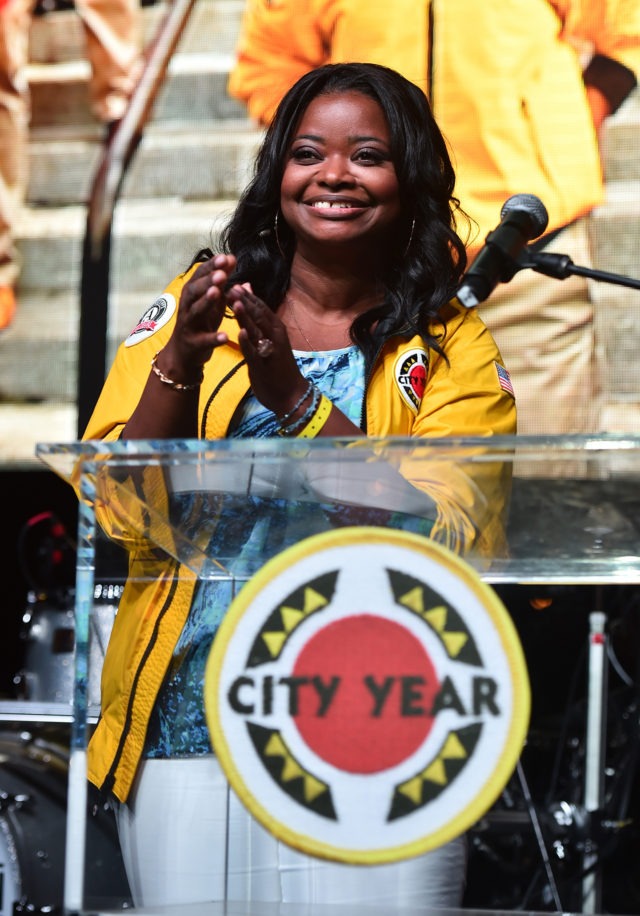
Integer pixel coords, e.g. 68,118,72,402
229,0,640,249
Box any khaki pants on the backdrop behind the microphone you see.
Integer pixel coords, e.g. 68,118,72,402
480,218,601,435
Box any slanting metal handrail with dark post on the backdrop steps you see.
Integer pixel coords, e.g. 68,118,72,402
76,0,195,438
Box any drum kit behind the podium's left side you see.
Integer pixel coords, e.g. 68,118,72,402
0,513,132,916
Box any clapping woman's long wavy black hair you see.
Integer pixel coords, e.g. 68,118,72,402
215,63,466,358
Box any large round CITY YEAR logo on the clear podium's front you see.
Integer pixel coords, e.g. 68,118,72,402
205,527,529,864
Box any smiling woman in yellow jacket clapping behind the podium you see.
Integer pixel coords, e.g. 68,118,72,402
86,64,515,906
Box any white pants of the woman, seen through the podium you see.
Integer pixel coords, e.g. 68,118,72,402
116,757,466,908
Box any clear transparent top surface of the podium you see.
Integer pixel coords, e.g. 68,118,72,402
37,435,640,583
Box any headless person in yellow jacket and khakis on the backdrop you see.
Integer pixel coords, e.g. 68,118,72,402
229,0,640,434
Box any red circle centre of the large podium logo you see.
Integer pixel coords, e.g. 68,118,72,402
292,614,440,773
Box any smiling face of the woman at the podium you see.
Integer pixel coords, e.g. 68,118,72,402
281,92,401,252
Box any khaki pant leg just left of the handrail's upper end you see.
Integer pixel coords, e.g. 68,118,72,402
76,0,142,123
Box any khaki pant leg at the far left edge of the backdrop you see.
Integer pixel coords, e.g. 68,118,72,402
0,0,33,286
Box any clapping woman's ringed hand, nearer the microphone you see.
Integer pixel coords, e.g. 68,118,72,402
227,284,307,417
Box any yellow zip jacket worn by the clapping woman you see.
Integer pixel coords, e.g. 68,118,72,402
85,266,516,801
